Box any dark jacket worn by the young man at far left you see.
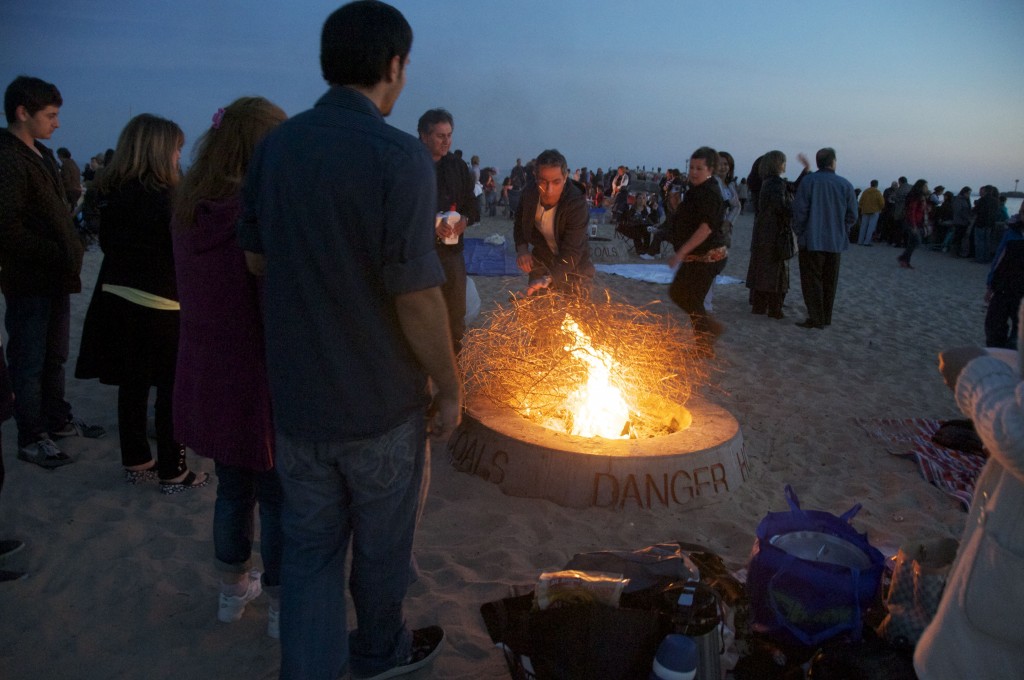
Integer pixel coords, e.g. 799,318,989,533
0,130,84,295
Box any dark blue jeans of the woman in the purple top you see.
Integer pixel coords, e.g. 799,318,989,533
213,463,282,586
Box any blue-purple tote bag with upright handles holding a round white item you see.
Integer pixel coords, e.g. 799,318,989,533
746,484,885,647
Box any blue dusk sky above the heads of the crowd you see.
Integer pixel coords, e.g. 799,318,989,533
0,0,1024,192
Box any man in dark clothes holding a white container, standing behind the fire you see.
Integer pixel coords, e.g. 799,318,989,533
416,109,480,354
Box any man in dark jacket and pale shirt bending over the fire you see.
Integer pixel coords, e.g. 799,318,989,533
513,148,594,295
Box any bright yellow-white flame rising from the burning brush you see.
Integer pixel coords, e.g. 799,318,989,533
559,314,630,439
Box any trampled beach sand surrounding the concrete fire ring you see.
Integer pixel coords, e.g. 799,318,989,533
0,209,987,680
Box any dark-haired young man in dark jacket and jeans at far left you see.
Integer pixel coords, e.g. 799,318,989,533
0,76,103,468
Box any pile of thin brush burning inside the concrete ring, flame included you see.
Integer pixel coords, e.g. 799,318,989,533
460,294,708,439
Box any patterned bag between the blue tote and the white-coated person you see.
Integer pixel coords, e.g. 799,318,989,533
879,539,959,646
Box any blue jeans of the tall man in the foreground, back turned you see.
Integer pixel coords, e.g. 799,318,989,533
276,413,429,680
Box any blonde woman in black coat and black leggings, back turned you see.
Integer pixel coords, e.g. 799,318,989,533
75,114,209,494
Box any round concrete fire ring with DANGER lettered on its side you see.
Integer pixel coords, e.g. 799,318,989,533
446,397,746,511
